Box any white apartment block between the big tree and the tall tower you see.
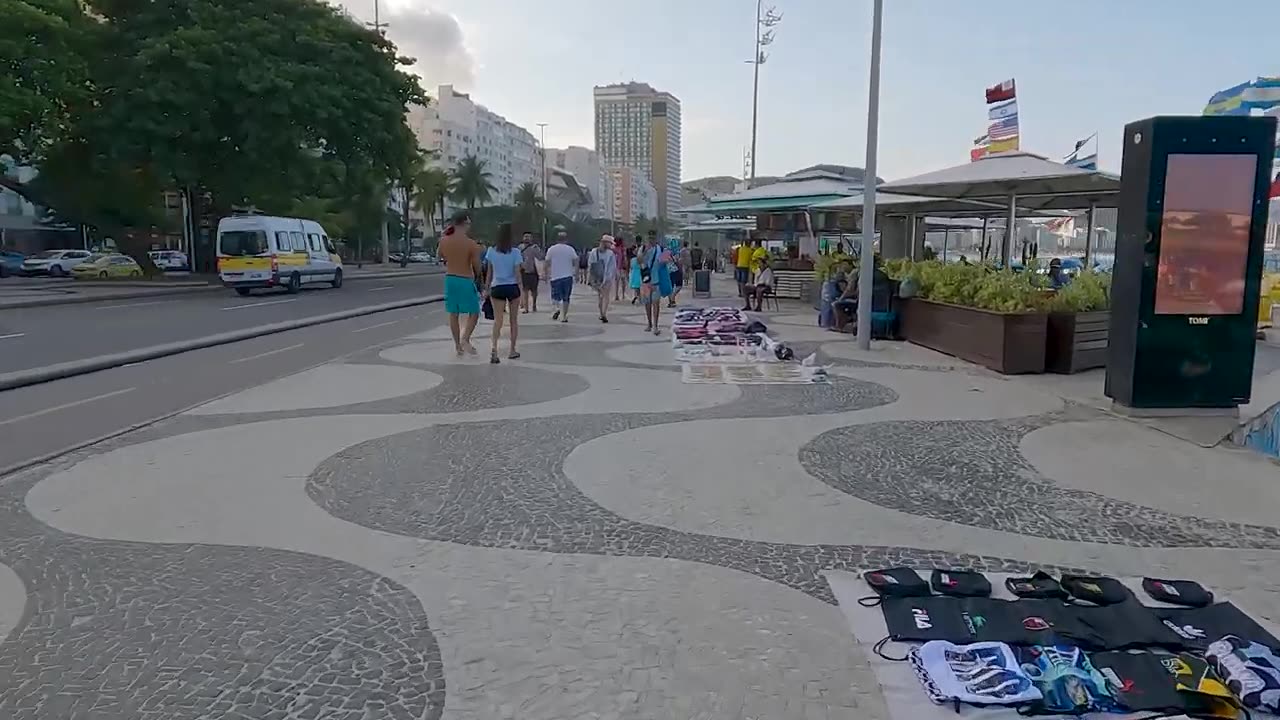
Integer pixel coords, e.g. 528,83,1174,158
408,85,543,205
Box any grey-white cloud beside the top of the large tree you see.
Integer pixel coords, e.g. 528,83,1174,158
338,0,477,89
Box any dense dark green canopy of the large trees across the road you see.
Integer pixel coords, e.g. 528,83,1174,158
0,0,426,257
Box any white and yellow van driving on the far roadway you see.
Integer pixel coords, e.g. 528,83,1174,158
218,215,342,295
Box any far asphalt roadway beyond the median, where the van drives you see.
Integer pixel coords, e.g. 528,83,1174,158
0,274,444,371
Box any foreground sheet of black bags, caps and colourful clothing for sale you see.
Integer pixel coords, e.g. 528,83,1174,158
824,568,1280,720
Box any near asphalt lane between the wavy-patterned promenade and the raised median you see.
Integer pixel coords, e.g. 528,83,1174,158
0,301,443,473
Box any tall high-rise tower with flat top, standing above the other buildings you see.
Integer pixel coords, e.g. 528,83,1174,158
595,82,681,218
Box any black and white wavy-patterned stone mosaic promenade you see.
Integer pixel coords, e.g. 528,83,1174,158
0,283,1280,720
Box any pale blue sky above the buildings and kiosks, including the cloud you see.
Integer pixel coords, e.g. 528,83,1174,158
338,0,1280,181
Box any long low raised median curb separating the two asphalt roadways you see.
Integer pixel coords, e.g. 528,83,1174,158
0,295,444,391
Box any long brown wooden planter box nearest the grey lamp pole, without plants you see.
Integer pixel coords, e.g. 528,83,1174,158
901,297,1047,375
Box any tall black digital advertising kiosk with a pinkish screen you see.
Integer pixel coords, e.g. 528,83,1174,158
1106,117,1276,414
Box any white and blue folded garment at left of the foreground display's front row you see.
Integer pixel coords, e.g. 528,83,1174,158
908,641,1042,706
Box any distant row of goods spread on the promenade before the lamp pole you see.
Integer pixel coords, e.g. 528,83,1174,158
671,302,828,384
